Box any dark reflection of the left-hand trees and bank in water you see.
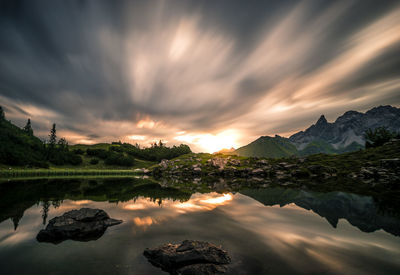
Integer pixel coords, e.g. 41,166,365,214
0,178,191,230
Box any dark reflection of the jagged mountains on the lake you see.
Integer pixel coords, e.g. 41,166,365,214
240,188,400,236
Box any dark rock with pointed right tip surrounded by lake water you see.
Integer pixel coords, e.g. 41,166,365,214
36,208,122,244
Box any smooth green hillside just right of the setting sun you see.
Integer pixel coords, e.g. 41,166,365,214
234,136,298,158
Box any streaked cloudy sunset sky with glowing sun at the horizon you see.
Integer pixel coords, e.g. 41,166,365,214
0,0,400,152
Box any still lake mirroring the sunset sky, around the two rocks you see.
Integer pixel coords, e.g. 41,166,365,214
0,178,400,274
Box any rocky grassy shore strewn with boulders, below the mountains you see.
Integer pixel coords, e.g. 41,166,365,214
149,140,400,193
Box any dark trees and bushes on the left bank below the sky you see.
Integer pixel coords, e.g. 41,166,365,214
0,106,191,168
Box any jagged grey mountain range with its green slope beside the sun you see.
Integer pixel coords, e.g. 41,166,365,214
234,105,400,158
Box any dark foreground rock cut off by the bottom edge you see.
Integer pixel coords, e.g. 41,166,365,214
143,240,231,275
